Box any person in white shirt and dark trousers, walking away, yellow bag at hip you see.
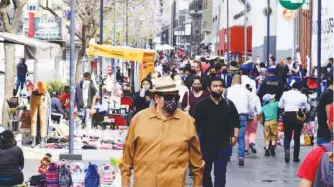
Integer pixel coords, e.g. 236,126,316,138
279,82,310,163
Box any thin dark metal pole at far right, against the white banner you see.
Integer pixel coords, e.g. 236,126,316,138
317,0,322,100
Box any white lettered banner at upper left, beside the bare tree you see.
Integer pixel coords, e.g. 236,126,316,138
34,17,62,41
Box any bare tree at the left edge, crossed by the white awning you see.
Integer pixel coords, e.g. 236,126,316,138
0,0,28,125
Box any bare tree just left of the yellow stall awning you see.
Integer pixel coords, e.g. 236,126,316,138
39,0,111,83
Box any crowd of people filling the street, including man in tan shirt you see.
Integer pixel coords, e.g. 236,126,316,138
120,56,333,187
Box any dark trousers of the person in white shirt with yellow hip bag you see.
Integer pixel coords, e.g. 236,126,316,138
283,112,303,158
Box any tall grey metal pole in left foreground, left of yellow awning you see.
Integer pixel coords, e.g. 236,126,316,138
69,0,75,155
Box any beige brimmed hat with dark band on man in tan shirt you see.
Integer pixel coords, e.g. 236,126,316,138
150,76,179,93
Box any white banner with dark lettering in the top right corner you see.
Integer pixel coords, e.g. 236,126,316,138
311,0,334,67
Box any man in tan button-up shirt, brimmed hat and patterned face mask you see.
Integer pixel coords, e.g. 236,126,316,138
120,77,204,187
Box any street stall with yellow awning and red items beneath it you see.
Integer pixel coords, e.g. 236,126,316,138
87,39,155,126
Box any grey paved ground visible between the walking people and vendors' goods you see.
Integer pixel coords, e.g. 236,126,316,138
23,126,312,187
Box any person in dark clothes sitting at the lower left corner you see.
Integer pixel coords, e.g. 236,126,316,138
0,130,24,186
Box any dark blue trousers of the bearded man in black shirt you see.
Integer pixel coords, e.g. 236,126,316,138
203,147,232,187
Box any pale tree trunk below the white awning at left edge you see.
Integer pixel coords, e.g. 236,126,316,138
2,44,16,126
